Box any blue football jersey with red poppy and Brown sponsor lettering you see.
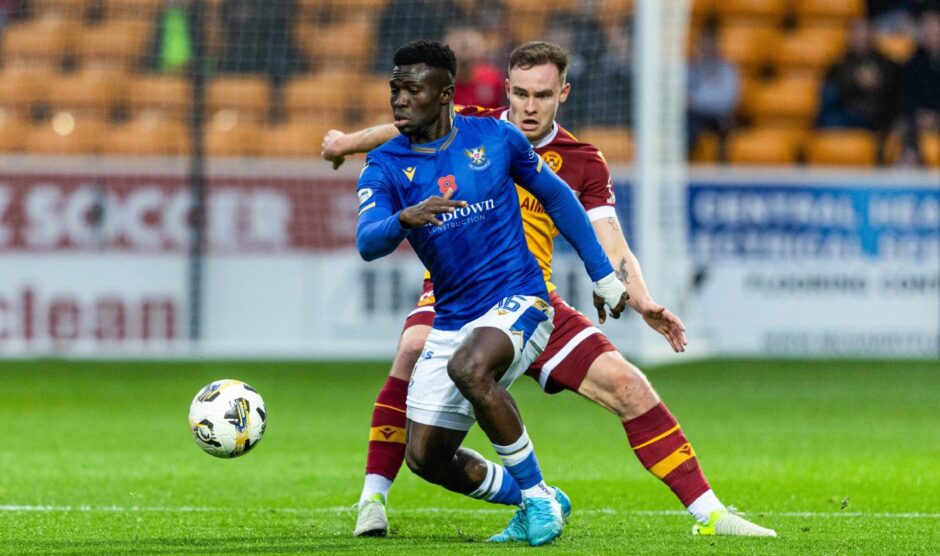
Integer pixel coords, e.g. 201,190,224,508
358,115,547,330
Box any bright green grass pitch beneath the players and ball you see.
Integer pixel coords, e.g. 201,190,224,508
0,360,940,555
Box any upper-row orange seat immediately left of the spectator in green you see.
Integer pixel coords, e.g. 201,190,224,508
77,20,152,69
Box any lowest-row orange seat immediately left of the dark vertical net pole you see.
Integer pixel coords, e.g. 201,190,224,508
101,115,189,156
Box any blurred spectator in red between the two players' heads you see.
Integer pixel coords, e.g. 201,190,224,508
443,27,504,108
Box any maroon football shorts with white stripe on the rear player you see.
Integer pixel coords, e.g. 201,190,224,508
402,280,617,394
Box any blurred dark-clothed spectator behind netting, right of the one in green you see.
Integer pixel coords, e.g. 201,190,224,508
219,0,307,81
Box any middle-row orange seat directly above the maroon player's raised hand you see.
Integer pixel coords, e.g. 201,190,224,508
284,71,360,121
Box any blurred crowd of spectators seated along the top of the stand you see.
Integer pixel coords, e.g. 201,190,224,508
0,0,940,165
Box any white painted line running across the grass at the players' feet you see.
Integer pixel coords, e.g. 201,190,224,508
0,504,940,519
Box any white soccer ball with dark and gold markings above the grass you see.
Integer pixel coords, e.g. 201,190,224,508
189,379,268,458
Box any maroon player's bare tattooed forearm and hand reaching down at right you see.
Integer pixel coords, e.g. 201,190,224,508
593,216,688,353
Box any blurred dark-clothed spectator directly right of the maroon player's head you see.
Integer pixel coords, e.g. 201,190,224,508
546,0,605,129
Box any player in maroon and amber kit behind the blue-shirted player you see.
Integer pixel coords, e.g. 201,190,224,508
322,41,776,542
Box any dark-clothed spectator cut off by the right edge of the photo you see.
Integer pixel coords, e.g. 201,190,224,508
900,9,940,165
